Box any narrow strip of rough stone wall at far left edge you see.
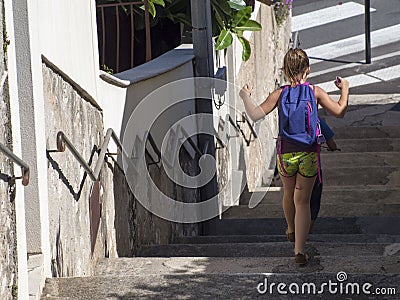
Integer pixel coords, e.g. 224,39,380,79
0,1,17,299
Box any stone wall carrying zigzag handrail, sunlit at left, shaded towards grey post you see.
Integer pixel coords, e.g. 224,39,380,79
43,56,200,268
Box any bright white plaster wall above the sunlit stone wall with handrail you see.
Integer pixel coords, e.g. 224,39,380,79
37,0,101,101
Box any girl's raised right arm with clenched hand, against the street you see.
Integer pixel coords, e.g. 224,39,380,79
315,77,349,118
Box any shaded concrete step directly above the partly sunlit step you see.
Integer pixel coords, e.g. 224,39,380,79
137,242,400,259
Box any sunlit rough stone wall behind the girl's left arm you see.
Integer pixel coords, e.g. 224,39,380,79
237,4,291,191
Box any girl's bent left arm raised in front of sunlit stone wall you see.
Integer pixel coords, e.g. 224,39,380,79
239,84,282,121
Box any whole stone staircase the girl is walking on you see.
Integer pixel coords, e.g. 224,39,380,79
42,126,400,299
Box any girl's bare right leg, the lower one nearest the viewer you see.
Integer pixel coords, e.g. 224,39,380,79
294,174,316,254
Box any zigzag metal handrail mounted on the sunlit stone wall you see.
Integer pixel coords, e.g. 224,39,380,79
53,128,122,181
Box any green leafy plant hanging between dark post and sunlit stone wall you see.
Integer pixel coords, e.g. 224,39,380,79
211,0,261,61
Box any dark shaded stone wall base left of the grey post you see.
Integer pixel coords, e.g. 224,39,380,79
114,144,200,257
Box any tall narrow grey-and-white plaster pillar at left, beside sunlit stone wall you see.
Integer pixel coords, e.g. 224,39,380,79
7,0,50,276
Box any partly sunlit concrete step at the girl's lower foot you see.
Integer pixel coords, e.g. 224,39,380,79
96,256,400,279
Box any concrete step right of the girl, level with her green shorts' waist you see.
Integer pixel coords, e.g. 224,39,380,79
321,151,400,170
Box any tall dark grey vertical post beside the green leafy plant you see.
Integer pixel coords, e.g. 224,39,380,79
190,0,218,234
